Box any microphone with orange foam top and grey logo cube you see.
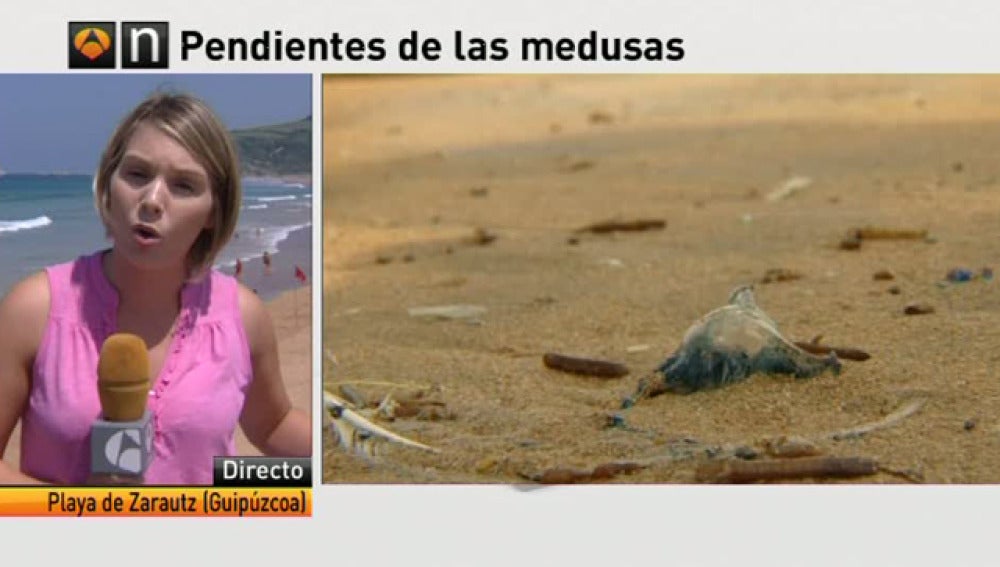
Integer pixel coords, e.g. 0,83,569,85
90,333,153,484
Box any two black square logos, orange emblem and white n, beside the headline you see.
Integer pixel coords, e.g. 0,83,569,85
68,22,170,69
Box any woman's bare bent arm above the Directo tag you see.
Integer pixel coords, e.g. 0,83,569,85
239,285,312,457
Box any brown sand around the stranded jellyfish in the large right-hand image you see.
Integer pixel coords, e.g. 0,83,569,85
323,75,1000,484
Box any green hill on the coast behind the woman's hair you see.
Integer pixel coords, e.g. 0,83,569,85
232,116,312,177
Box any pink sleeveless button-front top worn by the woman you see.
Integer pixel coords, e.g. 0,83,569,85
21,252,253,484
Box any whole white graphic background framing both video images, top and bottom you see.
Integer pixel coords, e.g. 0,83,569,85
0,0,1000,567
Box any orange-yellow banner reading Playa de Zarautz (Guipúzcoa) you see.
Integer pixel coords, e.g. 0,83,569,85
0,486,312,517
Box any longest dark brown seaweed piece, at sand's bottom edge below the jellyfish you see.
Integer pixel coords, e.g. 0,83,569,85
695,456,879,484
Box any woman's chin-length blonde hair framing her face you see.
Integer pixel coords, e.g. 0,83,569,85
94,93,242,279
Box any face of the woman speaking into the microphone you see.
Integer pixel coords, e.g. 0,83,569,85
107,124,213,269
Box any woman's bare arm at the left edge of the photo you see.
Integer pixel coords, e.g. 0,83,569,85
0,272,49,484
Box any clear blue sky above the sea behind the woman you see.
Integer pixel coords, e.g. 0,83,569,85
0,73,312,173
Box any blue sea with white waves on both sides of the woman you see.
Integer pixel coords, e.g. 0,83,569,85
0,173,312,297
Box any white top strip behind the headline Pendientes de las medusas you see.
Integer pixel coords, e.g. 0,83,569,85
0,0,1000,73
